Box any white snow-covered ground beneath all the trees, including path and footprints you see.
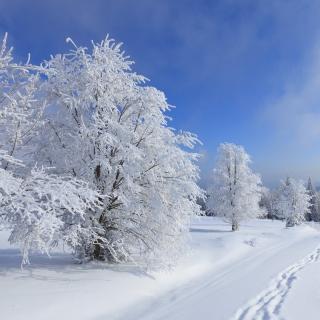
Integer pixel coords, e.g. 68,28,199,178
0,217,320,320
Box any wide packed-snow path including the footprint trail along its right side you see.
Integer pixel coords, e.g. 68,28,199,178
115,221,320,320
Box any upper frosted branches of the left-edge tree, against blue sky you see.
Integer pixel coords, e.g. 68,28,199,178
0,35,45,168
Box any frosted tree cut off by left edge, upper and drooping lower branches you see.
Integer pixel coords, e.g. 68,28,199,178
0,36,100,263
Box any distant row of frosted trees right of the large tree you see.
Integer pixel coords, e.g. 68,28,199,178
206,143,320,231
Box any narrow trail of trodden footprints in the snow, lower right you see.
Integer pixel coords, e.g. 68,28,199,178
234,248,320,320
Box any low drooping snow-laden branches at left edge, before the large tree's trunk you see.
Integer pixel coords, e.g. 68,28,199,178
0,157,99,264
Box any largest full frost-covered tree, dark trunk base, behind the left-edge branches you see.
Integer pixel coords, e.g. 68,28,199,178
32,38,202,263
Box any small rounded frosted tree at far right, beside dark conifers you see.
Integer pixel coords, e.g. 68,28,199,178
277,178,311,227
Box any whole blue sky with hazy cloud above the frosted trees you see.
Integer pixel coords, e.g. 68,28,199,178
0,0,320,186
